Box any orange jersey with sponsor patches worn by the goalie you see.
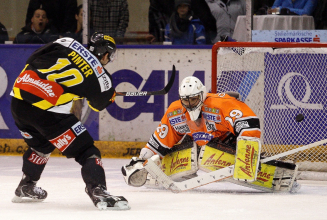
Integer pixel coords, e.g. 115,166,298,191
146,93,261,157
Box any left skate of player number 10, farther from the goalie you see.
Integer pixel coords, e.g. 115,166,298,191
11,176,48,203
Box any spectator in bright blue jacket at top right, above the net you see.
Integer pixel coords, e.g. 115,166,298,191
268,0,318,15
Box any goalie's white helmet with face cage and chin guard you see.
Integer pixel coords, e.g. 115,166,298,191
179,76,207,121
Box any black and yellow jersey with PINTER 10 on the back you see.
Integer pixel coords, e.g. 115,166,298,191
11,38,115,114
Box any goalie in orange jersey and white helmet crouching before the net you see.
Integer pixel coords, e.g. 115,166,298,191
122,76,300,192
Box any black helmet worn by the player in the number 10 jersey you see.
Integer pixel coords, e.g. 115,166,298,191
88,32,116,62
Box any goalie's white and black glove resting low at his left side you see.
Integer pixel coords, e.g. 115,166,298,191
121,157,148,187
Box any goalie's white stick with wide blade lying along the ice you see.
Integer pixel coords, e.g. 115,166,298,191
144,139,327,193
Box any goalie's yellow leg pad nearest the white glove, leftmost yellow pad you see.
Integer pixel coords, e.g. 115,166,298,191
161,141,198,181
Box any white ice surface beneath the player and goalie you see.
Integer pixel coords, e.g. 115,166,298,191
0,156,327,220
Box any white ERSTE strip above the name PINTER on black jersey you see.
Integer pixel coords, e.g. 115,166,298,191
69,41,104,77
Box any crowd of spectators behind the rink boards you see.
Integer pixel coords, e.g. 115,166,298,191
0,0,327,45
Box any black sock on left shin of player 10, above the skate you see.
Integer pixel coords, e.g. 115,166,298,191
23,148,50,181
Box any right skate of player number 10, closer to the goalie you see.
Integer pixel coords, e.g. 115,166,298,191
85,185,130,210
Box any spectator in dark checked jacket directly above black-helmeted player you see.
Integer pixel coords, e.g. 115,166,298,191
89,0,129,37
